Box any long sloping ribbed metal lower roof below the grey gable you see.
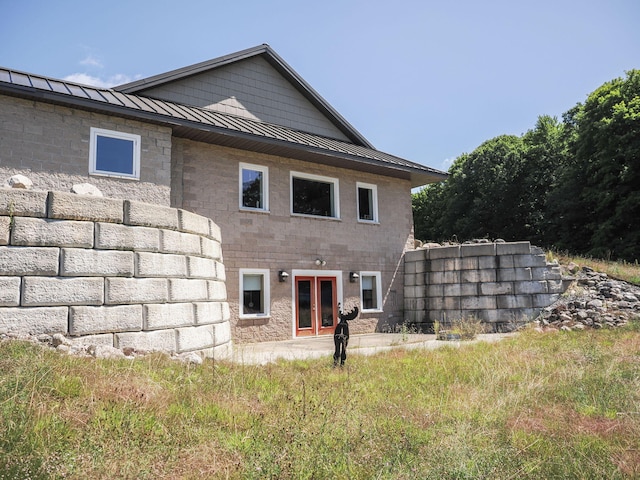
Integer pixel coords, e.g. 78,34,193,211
0,63,448,187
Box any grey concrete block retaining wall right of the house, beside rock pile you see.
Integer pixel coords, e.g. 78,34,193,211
404,242,569,331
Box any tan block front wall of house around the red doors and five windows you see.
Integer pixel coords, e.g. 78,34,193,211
173,139,413,342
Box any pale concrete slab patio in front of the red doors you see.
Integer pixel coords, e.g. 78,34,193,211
232,333,513,365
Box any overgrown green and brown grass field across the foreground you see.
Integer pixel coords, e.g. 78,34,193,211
0,320,640,479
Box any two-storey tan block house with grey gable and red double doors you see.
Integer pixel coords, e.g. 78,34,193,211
0,45,447,342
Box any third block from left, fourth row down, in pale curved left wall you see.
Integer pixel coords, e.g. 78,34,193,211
104,277,169,305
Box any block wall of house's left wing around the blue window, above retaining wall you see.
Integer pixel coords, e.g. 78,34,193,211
0,95,171,206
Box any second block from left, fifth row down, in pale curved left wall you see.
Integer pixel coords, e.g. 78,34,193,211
69,305,142,336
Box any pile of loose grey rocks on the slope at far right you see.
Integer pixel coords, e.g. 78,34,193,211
536,265,640,331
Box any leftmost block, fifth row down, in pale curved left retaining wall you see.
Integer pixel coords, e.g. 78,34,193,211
0,307,69,335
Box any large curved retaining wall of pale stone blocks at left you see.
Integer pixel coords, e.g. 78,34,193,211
0,188,231,358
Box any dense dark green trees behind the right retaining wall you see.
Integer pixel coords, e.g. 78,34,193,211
413,70,640,261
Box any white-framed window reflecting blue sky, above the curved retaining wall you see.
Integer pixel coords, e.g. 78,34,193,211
89,128,140,179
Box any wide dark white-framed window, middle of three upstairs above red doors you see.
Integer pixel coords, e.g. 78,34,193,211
291,172,340,218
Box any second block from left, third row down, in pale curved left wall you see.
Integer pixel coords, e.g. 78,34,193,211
60,248,134,277
